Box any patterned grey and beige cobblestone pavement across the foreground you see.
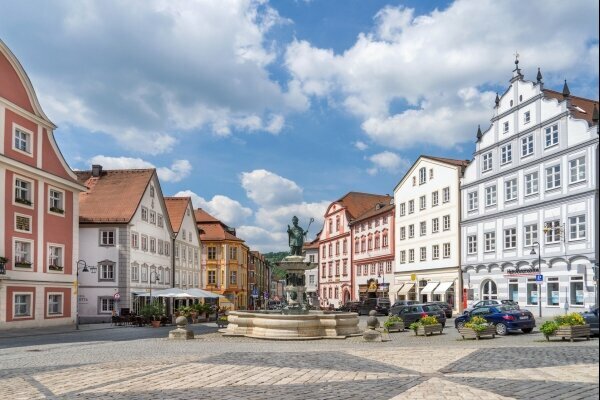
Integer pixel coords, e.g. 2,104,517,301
0,325,599,400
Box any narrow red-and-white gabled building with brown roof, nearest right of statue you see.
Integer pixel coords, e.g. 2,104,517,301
319,192,391,308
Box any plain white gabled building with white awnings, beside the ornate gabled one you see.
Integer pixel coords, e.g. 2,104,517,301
392,156,468,311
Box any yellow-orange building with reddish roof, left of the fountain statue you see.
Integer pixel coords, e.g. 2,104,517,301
194,208,249,310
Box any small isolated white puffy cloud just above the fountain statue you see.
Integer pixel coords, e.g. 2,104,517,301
240,169,302,207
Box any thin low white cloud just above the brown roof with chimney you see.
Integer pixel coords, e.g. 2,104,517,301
88,155,192,182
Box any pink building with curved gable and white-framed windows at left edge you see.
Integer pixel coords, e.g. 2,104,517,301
0,40,83,329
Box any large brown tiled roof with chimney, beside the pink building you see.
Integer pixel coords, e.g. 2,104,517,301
75,169,155,223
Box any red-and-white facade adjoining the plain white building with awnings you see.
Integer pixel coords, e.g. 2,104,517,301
350,202,395,301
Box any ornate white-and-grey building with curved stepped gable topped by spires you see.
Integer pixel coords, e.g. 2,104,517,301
461,61,598,316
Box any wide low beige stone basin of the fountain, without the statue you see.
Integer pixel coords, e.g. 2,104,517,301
219,311,361,340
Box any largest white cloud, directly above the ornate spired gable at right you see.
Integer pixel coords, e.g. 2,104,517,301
285,0,598,148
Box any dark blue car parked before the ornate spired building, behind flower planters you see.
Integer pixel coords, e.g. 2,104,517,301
454,306,535,335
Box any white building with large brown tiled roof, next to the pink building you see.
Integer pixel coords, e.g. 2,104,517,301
77,165,173,322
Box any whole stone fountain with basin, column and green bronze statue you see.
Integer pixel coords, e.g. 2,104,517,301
219,216,361,340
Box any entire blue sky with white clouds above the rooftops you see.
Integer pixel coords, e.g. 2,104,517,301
0,0,599,251
